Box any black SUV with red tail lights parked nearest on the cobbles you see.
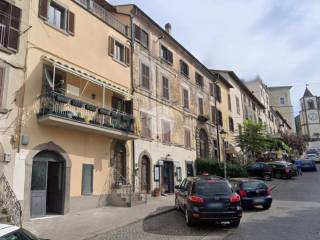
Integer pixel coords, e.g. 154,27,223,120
175,176,242,227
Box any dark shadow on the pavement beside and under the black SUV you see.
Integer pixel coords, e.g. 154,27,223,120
143,207,230,236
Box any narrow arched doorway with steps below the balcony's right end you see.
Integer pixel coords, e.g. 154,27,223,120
114,143,127,185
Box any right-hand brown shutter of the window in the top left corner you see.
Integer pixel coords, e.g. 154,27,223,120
7,5,21,52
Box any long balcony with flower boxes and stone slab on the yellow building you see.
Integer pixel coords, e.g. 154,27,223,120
37,92,137,140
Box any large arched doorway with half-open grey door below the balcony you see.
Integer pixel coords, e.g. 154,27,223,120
30,151,66,217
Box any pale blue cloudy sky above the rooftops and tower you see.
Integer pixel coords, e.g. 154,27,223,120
110,0,320,114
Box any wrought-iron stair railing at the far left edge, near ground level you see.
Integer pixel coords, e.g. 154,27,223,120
0,174,22,227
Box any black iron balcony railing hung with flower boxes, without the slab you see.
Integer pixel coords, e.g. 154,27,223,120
38,93,134,133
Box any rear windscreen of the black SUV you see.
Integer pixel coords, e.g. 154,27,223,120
194,180,232,197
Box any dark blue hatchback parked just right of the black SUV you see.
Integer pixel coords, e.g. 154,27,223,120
230,178,272,209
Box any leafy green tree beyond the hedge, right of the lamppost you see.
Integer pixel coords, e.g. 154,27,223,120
235,120,269,161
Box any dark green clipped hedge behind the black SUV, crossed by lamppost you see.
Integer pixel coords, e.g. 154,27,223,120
196,159,248,178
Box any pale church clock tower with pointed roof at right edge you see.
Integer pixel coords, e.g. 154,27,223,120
300,87,320,140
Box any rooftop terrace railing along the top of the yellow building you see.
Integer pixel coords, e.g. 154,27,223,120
74,0,130,37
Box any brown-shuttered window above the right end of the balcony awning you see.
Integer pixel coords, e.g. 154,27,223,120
108,36,131,66
